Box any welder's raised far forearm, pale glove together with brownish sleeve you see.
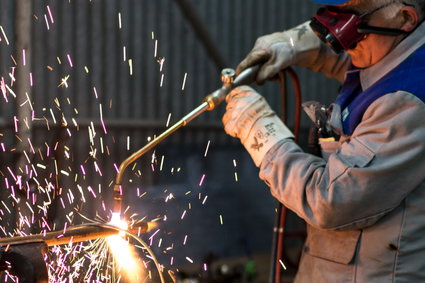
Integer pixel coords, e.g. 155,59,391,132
236,22,350,85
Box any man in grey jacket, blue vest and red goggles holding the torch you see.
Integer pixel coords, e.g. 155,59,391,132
223,0,425,282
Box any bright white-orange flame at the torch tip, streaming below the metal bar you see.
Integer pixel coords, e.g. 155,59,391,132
107,213,143,282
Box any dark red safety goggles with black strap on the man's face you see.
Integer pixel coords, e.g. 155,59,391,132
310,3,407,53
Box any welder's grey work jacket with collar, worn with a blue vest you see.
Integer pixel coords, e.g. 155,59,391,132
260,21,425,282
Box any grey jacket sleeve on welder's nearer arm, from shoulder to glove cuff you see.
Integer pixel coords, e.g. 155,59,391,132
260,92,425,230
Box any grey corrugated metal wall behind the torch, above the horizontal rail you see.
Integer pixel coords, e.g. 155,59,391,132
1,0,340,142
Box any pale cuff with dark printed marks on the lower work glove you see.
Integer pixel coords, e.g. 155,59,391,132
241,114,294,167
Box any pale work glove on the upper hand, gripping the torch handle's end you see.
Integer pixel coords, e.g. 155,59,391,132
236,23,321,84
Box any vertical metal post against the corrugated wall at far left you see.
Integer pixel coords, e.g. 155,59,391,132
14,0,32,233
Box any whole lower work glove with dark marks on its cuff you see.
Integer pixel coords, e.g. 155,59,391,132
222,86,294,166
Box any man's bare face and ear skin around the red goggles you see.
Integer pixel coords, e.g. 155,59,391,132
340,1,404,68
